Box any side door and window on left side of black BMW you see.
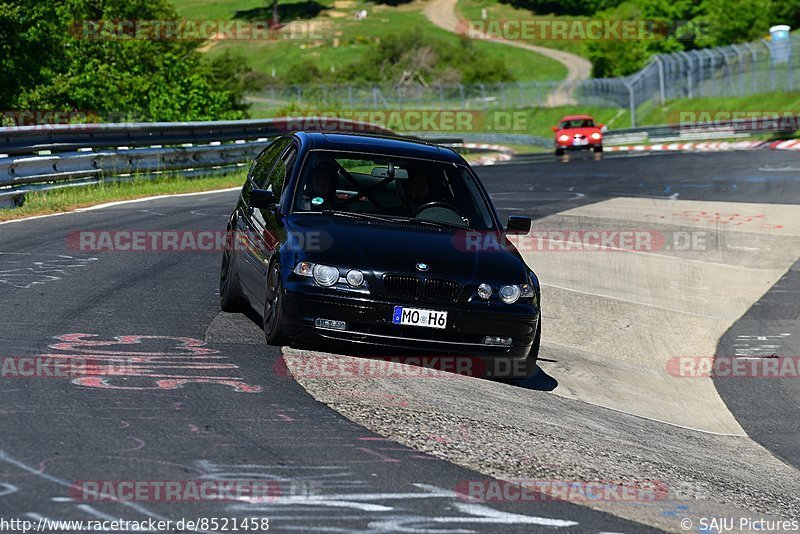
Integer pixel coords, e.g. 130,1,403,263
238,137,292,302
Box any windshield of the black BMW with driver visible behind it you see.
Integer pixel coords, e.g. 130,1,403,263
293,151,494,230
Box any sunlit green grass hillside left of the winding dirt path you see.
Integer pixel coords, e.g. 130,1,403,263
173,0,566,81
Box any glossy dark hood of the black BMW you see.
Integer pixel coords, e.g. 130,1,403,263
281,213,528,283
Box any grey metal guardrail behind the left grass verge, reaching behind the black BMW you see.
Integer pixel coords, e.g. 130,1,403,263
0,118,468,209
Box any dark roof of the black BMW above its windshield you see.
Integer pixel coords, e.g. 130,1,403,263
295,132,464,165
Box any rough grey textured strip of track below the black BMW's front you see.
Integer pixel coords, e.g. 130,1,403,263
284,348,800,532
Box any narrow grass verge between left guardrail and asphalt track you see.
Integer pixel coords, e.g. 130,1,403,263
0,171,245,221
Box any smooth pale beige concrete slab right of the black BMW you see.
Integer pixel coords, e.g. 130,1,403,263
518,198,800,435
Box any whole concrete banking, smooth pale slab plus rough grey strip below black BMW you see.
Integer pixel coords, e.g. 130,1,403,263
284,198,800,532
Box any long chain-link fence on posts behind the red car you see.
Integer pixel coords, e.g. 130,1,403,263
248,36,800,127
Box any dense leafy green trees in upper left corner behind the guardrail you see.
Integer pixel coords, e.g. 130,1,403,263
0,0,246,121
